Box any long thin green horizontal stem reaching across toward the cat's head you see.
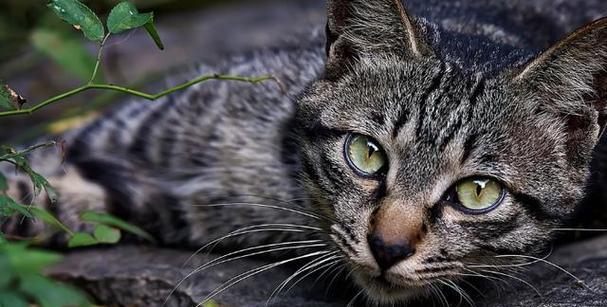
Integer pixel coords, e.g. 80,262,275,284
0,74,282,117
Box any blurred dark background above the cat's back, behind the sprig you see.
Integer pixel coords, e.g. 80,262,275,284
0,0,324,145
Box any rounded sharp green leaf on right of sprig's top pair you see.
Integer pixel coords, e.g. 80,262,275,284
107,1,154,34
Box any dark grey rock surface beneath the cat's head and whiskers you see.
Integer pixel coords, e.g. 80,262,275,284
51,236,607,307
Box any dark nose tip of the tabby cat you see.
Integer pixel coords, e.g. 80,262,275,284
367,234,415,271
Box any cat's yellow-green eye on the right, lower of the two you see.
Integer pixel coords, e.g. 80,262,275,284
455,178,504,213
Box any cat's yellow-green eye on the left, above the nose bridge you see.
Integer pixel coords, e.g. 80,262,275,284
345,134,387,176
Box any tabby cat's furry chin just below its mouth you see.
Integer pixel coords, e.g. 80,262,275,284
353,272,428,304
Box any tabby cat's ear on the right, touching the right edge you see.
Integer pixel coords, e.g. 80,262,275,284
512,18,607,165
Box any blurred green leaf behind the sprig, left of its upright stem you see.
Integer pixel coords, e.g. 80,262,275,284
31,28,96,80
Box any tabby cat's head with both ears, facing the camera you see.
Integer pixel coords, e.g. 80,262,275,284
297,0,607,302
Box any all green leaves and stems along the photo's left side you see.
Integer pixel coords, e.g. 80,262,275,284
0,0,272,307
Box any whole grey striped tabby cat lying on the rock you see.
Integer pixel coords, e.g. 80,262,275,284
2,0,607,304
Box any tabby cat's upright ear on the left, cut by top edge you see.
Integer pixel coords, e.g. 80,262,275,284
326,0,432,75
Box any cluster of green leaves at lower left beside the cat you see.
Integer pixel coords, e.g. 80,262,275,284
0,142,154,307
